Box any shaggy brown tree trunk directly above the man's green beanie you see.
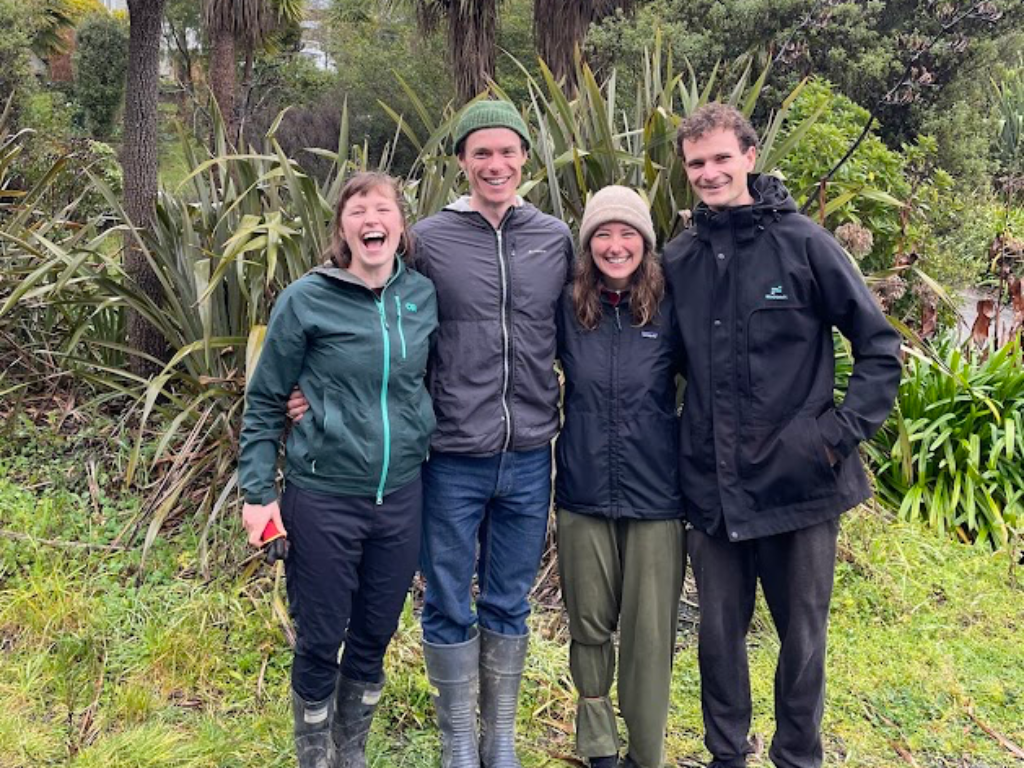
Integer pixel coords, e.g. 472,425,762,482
447,0,498,102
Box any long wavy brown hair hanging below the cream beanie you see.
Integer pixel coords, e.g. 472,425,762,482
572,241,665,331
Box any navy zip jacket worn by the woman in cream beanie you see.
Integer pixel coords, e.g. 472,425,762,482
555,288,683,520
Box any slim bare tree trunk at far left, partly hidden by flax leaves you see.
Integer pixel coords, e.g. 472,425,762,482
121,0,167,376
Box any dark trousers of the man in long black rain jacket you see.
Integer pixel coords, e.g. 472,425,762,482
688,519,839,768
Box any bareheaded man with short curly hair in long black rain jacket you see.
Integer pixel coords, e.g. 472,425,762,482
666,104,900,768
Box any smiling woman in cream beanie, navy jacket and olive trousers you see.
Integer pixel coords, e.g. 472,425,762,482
555,186,685,768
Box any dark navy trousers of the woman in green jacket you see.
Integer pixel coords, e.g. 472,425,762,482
281,478,423,701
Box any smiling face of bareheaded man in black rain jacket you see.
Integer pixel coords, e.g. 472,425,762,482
682,128,757,211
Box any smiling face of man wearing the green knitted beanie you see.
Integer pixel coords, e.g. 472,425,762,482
459,128,526,226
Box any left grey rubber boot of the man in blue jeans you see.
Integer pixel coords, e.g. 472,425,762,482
423,635,480,768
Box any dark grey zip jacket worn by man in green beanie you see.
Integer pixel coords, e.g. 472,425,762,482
412,198,572,456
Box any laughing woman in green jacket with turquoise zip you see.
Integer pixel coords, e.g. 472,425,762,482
239,173,437,768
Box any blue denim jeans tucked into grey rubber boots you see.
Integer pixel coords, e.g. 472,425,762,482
420,445,551,645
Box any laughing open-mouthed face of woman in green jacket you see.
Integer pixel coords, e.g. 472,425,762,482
340,186,406,288
